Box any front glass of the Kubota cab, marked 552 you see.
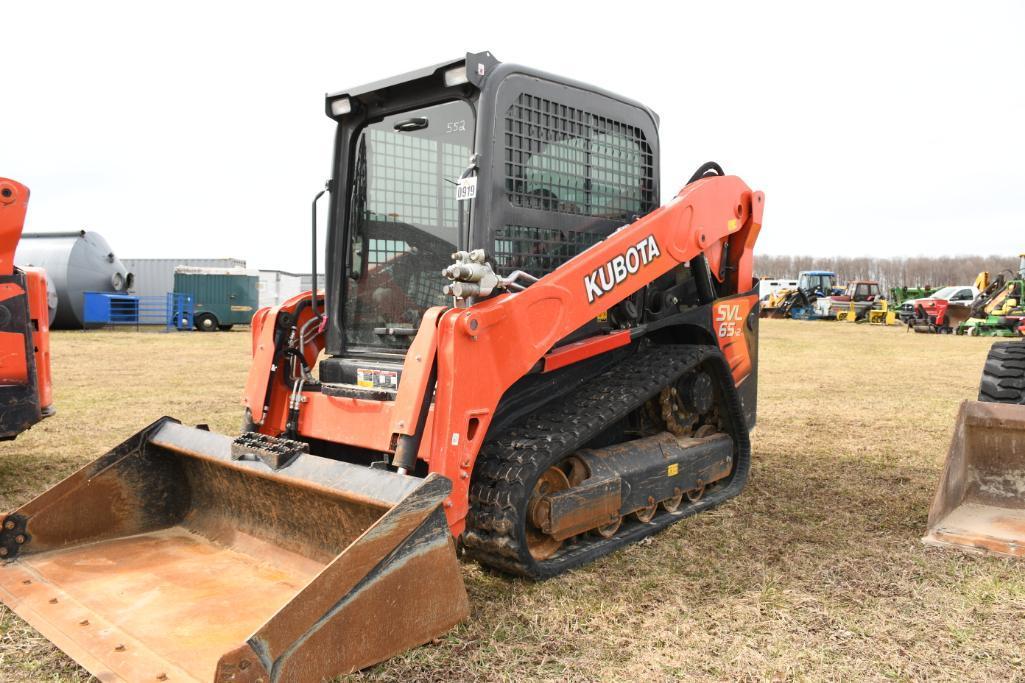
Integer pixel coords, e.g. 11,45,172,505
344,101,474,349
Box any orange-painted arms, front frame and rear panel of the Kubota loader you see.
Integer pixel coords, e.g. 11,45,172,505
244,176,764,535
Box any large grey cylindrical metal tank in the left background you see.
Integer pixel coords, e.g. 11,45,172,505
14,230,133,329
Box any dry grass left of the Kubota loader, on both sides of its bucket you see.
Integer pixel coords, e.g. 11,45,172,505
0,330,250,681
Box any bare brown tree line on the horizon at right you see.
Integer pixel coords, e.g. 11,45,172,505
754,254,1019,290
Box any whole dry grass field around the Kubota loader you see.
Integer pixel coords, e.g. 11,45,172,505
0,321,1025,681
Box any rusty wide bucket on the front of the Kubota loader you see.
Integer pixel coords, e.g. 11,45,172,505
0,418,468,682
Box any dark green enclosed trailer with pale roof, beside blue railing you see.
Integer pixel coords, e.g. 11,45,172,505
174,266,259,332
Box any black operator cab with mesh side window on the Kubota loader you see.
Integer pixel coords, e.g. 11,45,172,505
320,52,660,399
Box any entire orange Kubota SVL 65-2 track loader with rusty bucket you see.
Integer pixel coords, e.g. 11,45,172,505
0,52,764,681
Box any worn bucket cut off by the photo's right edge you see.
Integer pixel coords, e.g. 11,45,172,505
923,401,1025,557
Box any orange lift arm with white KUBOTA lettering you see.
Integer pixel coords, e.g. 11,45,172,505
426,170,764,534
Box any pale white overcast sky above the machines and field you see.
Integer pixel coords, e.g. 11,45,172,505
0,0,1025,271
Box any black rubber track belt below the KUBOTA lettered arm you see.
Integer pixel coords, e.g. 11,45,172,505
463,345,750,578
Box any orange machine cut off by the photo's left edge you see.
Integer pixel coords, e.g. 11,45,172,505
0,177,54,441
